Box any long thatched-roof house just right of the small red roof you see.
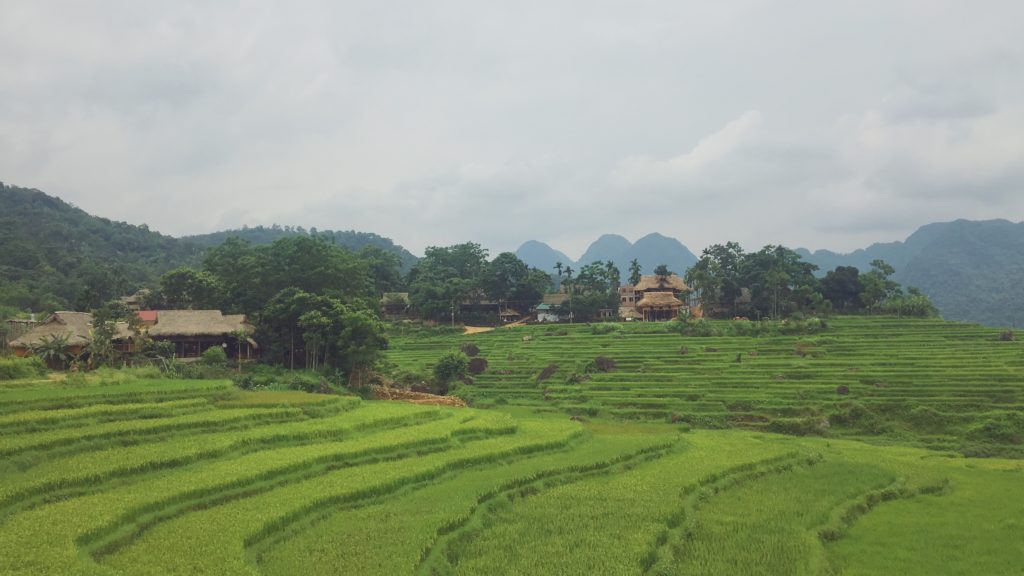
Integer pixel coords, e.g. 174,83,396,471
139,310,259,360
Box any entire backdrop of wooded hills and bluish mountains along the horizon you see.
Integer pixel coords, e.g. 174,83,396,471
0,182,1024,327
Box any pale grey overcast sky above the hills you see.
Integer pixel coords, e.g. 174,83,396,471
0,0,1024,257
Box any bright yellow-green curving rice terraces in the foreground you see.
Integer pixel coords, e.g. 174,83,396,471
0,368,1024,575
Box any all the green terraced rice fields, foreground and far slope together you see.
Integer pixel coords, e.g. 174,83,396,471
0,319,1024,575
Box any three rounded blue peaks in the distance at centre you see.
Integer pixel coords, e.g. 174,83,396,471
515,233,697,278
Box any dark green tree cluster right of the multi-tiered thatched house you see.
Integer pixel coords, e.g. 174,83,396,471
686,242,938,320
